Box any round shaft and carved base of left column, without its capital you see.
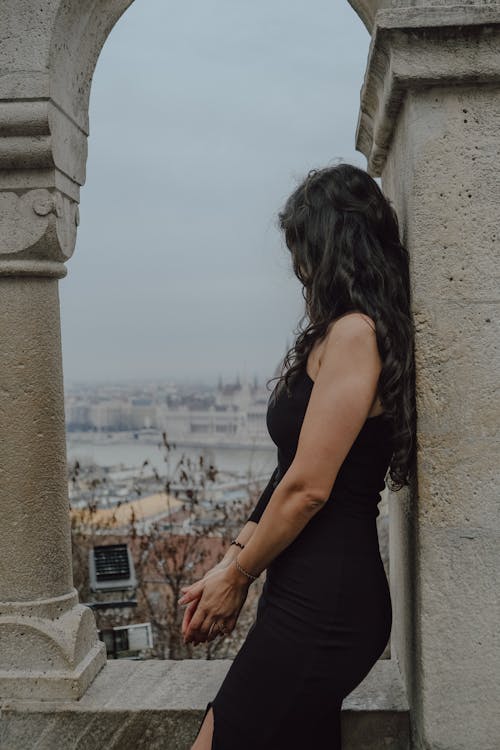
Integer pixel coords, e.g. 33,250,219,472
0,278,105,699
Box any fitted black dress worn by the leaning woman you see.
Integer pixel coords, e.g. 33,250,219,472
195,370,392,750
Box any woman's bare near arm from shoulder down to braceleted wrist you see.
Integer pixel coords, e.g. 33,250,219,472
229,313,381,581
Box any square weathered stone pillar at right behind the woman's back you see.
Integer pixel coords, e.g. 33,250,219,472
351,1,500,750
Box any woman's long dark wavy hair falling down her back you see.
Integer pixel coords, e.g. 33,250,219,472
267,163,416,492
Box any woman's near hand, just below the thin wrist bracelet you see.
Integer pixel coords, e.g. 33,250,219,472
179,563,251,645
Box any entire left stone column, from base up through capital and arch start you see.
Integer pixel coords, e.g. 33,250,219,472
0,0,131,700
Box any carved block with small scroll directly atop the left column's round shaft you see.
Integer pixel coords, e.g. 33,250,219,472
0,188,79,277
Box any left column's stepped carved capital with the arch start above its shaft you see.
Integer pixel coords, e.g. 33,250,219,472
0,0,132,277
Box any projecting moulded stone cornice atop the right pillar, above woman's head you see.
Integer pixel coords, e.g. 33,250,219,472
356,3,500,176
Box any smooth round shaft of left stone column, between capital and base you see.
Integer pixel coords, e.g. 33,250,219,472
0,278,73,604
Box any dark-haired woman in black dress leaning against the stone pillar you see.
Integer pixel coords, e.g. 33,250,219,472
180,163,415,750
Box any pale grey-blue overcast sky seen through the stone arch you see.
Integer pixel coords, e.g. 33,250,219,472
60,0,369,382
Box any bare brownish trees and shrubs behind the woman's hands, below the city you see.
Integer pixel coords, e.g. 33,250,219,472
70,432,263,659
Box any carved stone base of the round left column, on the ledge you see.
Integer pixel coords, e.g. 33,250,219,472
0,591,106,701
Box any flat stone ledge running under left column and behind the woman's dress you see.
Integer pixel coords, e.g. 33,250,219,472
0,659,409,750
